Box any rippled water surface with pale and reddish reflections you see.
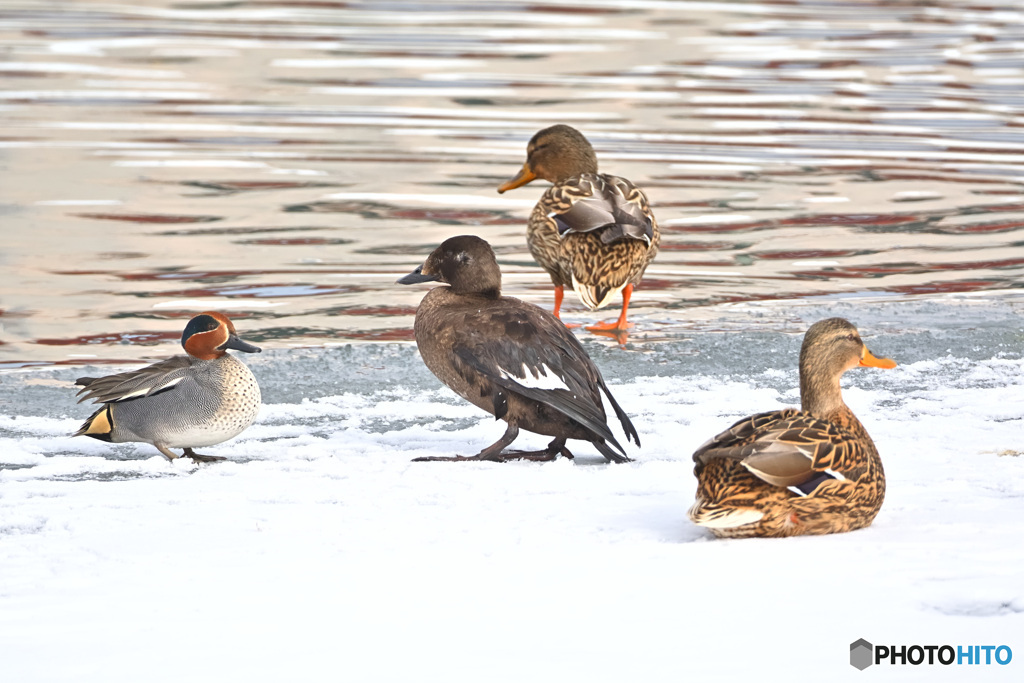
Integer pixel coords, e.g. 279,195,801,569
0,0,1024,367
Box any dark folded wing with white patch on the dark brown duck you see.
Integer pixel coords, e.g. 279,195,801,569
453,305,640,460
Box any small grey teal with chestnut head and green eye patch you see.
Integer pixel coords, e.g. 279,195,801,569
74,311,261,462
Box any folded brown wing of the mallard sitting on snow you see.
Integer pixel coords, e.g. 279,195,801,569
693,409,858,495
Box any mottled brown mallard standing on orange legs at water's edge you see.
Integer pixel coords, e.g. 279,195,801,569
498,124,660,332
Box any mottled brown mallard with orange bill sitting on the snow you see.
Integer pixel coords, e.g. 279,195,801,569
689,317,896,538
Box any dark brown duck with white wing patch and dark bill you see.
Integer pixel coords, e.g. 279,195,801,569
398,236,640,463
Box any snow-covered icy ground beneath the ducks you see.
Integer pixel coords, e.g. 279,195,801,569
0,295,1024,681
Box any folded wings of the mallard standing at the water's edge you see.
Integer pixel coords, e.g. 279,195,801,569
549,173,654,246
